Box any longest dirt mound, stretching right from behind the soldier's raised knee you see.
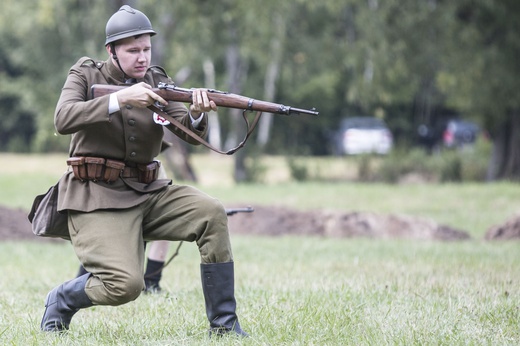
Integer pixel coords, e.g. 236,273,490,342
229,206,470,240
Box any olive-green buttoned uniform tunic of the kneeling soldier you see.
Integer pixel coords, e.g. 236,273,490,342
54,57,207,211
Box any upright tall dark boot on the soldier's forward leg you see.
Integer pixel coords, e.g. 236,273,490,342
200,262,249,337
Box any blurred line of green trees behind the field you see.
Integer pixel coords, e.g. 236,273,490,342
0,0,520,179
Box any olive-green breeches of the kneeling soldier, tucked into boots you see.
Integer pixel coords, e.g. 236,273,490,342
68,186,233,305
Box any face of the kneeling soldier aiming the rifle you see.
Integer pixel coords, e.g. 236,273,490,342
109,35,152,79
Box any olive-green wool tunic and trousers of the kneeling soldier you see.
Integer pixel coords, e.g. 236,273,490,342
54,57,233,305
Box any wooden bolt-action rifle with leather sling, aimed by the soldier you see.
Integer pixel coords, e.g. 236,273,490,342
91,83,319,155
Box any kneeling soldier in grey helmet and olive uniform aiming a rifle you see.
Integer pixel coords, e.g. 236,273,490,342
41,5,247,336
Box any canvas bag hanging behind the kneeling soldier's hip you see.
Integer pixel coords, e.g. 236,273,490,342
28,184,70,240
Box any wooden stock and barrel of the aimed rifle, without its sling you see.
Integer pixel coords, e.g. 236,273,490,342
91,83,319,115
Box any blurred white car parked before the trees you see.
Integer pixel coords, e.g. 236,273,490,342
336,116,393,155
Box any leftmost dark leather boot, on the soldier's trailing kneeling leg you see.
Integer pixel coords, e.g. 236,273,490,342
41,273,93,332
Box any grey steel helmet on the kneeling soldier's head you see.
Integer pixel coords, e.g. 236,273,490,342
105,5,156,46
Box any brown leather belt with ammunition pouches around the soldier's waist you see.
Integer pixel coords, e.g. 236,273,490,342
67,156,161,184
